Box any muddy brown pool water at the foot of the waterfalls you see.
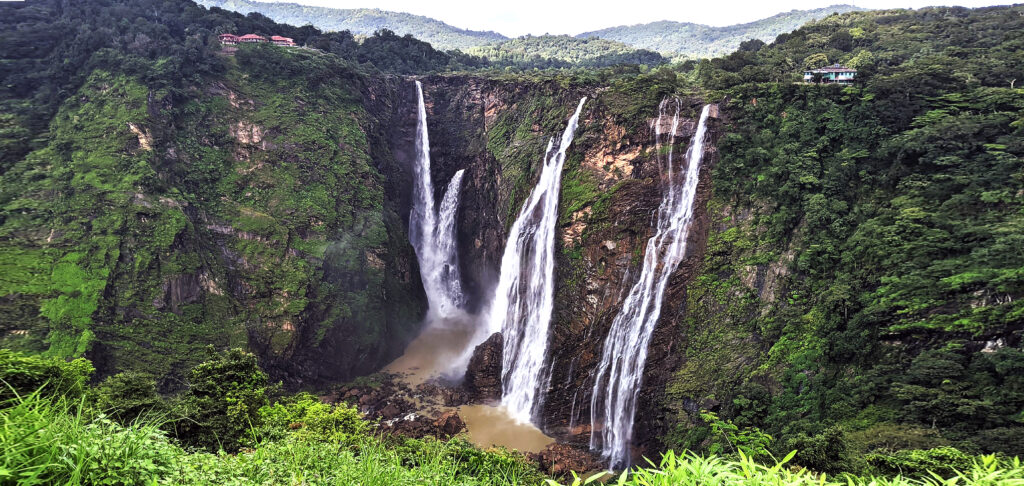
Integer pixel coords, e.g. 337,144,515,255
384,315,554,452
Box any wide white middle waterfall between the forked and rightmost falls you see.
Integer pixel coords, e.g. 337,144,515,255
487,97,587,422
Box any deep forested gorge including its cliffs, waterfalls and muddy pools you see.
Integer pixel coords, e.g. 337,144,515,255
0,0,1024,484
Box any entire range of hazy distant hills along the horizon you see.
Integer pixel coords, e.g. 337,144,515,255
196,0,863,60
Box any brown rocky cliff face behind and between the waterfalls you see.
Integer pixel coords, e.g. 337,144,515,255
403,77,722,460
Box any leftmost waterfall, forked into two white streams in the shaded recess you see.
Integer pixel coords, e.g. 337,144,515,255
409,81,465,319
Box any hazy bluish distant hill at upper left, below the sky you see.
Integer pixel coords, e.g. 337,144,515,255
196,0,508,50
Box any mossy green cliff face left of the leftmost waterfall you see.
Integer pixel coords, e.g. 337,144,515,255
0,49,425,389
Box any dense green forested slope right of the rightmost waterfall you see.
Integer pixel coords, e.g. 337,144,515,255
666,1,1024,474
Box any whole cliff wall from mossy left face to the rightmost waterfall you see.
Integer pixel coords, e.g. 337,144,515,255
0,44,717,452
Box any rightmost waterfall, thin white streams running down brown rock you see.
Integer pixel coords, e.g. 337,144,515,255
590,99,711,468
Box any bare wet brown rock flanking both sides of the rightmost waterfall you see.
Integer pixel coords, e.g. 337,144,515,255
542,99,722,460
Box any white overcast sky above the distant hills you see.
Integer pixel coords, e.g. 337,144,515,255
264,0,1007,37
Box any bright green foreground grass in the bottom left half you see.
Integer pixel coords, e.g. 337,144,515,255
0,392,542,486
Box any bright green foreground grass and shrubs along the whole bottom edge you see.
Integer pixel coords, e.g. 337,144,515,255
0,382,1024,486
